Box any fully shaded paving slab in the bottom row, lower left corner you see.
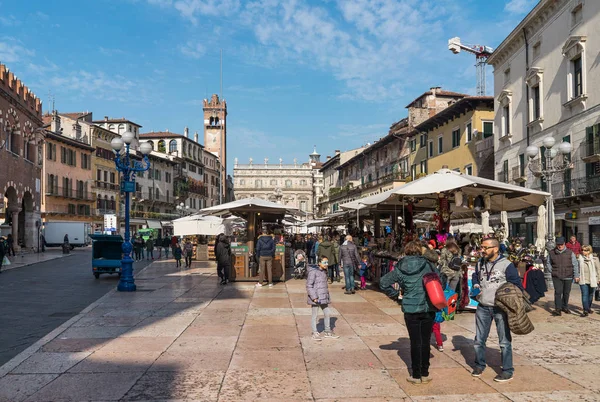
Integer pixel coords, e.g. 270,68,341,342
27,371,142,402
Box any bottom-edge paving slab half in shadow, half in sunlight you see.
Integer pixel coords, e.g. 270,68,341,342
122,371,225,401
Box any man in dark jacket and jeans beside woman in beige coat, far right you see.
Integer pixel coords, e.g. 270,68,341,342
546,237,579,316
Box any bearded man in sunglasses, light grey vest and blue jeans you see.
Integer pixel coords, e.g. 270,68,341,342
471,237,523,382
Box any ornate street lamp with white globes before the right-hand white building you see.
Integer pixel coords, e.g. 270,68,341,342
525,136,572,249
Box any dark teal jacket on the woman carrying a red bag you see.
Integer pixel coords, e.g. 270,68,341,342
379,255,437,313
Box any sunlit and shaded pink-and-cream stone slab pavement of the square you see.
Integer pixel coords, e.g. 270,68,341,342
0,261,600,402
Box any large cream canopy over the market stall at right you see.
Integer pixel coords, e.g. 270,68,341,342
358,169,550,211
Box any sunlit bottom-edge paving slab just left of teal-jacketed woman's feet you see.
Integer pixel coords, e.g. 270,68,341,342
308,369,407,401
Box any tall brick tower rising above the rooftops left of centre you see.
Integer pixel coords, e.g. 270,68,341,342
202,94,227,201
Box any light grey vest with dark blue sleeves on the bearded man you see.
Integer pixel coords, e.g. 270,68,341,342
471,255,523,307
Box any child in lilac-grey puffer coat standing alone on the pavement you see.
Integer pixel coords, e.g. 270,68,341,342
306,257,339,342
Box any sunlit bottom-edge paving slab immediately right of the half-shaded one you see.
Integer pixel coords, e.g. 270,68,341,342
219,370,312,401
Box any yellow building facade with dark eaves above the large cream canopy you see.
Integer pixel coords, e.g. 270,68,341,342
412,96,494,176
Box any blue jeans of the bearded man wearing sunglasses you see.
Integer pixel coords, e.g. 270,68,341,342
475,305,515,376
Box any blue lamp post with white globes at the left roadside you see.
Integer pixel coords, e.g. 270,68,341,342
110,131,152,292
